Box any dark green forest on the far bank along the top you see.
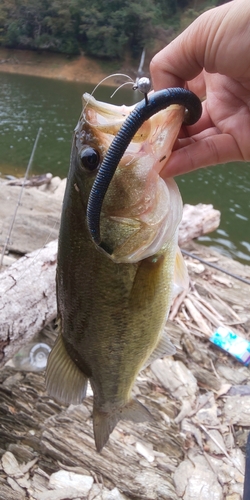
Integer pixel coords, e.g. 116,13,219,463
0,0,228,59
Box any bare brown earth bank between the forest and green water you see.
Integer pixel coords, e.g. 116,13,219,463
0,47,134,86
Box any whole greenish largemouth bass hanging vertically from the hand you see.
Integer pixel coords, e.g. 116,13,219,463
46,88,202,451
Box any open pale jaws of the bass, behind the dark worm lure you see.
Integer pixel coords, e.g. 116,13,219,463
83,89,185,173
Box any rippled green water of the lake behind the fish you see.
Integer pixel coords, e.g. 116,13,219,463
0,73,250,264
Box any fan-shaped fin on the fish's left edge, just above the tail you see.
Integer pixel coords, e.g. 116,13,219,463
46,334,88,405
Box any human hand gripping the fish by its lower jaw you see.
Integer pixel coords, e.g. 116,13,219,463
150,0,250,178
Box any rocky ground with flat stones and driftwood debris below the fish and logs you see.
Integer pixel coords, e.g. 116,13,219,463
0,179,250,500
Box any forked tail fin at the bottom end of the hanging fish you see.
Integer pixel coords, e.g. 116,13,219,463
93,399,154,452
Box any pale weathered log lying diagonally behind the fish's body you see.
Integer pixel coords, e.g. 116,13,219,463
0,204,220,366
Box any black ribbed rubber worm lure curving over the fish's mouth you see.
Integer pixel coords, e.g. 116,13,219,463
87,87,202,253
